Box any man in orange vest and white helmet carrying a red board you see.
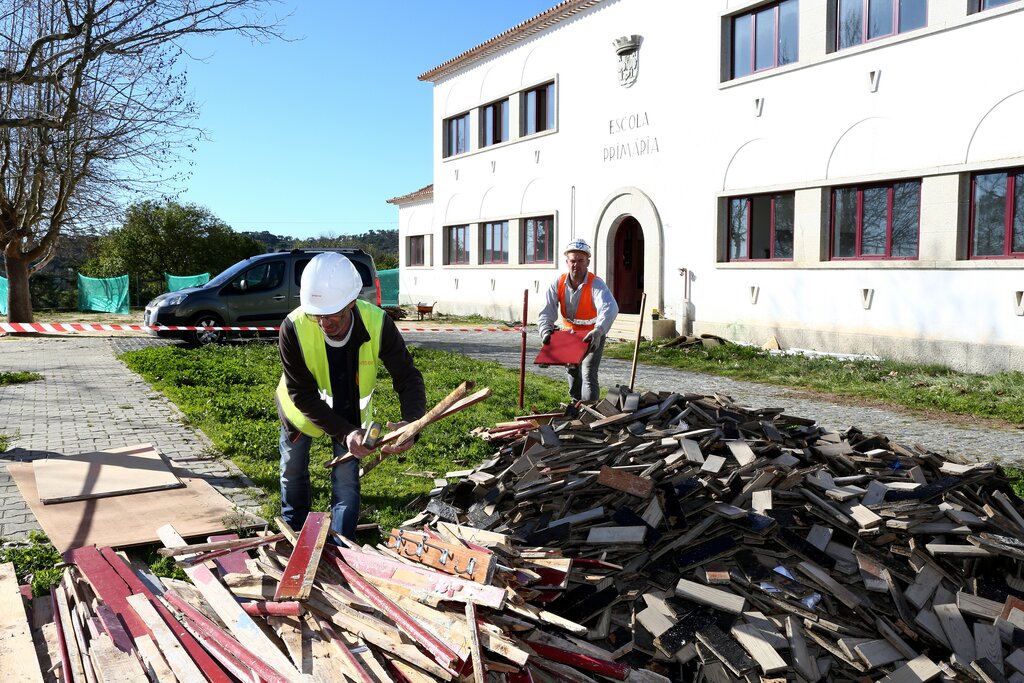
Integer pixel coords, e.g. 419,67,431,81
537,240,618,400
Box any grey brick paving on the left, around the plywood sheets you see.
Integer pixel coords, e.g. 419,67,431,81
0,335,262,539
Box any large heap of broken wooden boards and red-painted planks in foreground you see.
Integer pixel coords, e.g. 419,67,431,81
6,390,1024,683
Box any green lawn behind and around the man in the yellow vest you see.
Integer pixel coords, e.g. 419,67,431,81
121,343,567,529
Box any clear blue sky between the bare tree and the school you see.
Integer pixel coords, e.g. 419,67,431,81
178,0,557,238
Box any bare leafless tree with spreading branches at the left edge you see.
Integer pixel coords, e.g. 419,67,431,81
0,0,279,323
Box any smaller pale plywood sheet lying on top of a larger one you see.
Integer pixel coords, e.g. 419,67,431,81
32,443,184,505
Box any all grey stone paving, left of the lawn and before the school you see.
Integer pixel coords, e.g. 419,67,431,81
0,324,1024,538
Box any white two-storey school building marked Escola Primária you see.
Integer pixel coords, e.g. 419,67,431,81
390,0,1024,372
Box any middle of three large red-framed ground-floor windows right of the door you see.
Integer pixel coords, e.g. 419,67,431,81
831,180,921,259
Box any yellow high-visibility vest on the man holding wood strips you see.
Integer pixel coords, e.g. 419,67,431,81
278,299,386,437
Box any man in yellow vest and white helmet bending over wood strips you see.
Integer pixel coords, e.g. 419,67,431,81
276,252,427,539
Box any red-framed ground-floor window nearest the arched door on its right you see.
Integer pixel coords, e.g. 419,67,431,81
729,193,795,261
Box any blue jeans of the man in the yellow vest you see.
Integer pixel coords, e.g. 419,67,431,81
278,427,359,541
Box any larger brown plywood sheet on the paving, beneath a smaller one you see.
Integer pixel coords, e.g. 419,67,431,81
7,463,266,552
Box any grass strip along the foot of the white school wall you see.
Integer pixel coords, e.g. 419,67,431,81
605,342,1024,425
